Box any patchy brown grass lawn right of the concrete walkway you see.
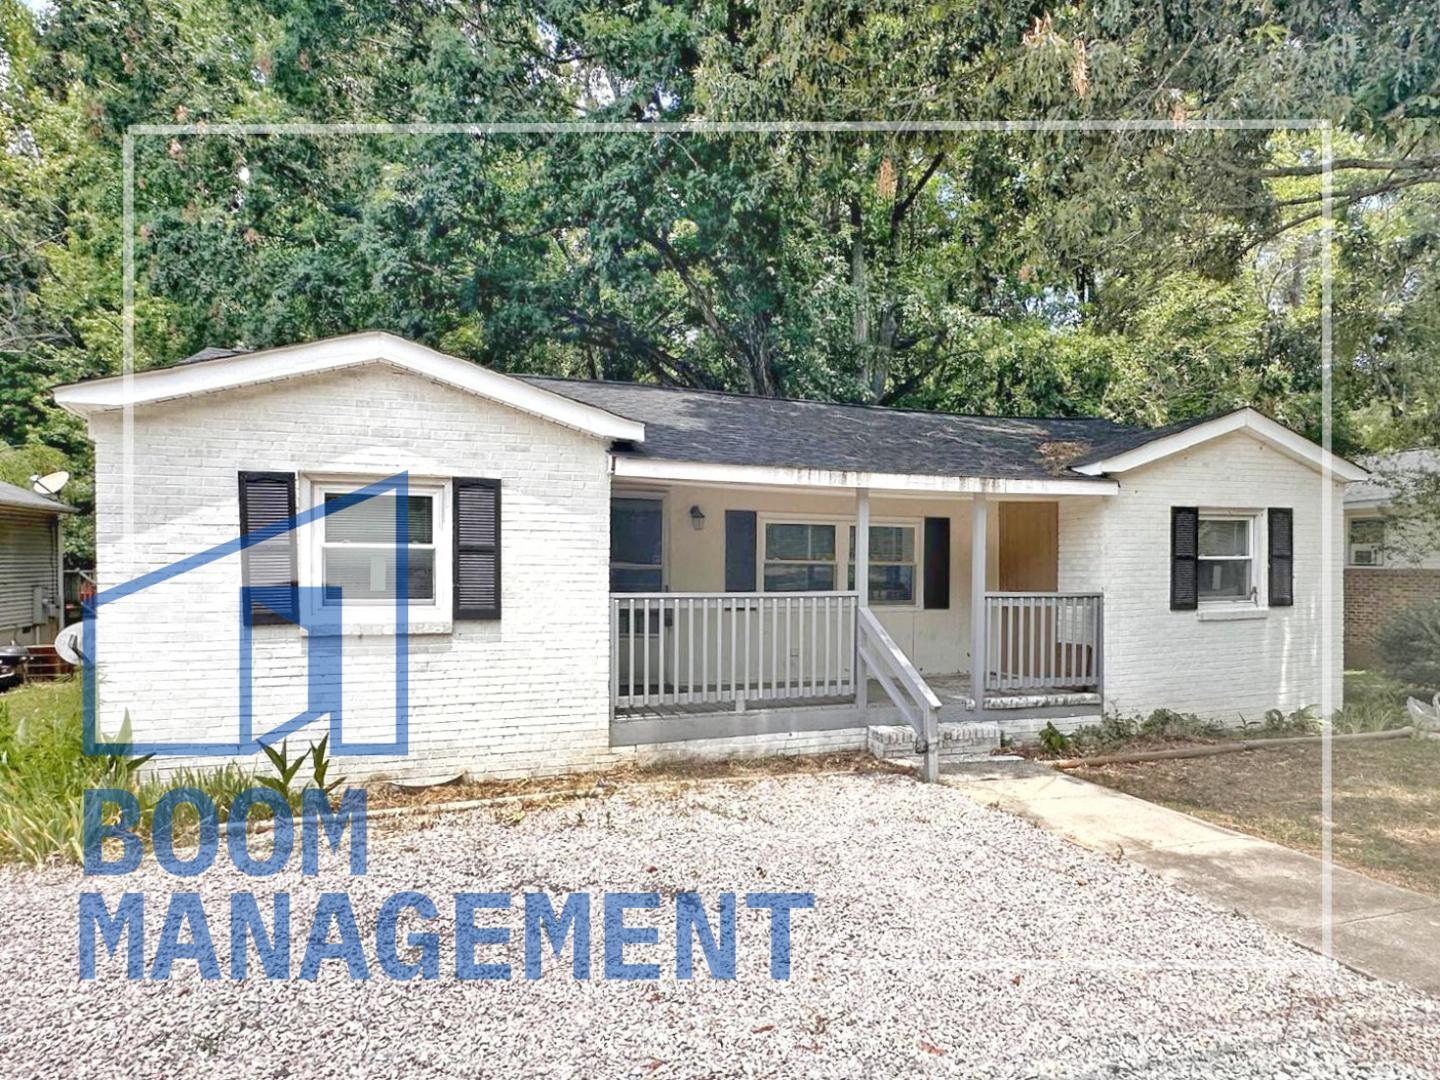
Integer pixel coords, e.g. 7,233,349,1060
1077,739,1440,896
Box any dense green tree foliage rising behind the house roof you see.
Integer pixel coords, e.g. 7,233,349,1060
0,0,1440,567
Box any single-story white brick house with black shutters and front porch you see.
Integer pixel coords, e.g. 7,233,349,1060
56,333,1365,779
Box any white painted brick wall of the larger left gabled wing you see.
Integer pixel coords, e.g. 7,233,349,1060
84,366,612,780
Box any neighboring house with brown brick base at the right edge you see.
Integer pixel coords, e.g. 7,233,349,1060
1345,449,1440,668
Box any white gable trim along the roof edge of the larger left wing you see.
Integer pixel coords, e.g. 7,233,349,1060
55,331,645,442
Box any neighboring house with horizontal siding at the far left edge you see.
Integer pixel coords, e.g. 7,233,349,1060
0,482,75,645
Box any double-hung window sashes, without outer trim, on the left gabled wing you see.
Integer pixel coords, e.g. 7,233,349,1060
315,484,441,606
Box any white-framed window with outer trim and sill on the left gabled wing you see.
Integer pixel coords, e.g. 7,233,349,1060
301,477,454,625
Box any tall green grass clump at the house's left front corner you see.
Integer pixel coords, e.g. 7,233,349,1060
0,680,251,864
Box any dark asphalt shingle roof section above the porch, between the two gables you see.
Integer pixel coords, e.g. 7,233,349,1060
523,376,1192,480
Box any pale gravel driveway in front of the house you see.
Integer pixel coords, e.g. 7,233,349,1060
0,775,1440,1077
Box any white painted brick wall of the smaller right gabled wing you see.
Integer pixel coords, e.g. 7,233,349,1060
1060,432,1344,721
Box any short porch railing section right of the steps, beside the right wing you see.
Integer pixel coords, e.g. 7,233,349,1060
985,592,1104,691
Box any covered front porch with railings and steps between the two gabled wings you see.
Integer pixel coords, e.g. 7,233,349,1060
611,478,1104,775
